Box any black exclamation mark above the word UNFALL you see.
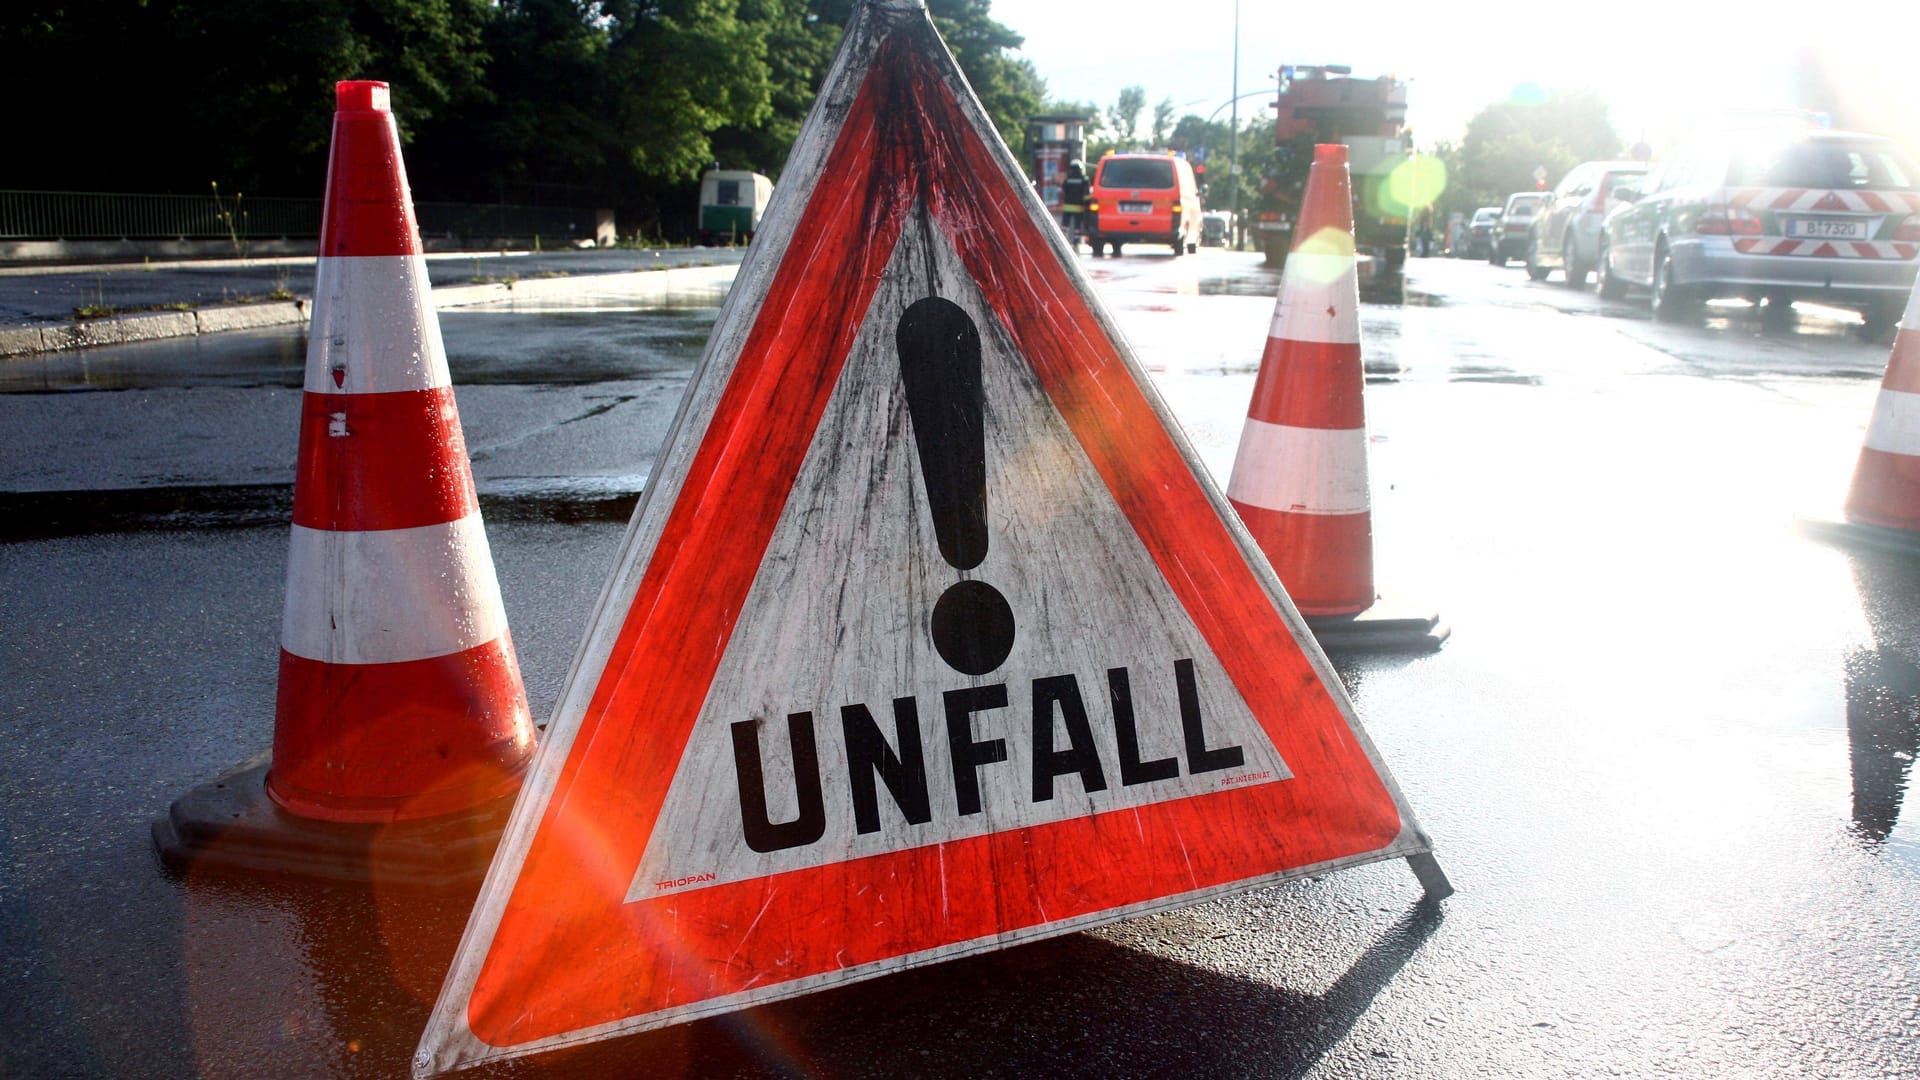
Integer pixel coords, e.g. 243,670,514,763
893,296,1014,675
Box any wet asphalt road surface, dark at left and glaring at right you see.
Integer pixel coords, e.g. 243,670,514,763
0,252,1920,1078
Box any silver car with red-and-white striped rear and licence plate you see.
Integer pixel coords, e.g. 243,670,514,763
1597,131,1920,340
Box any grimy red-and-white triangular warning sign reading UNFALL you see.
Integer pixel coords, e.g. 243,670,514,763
415,0,1428,1074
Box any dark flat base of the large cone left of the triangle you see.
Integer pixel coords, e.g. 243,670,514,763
152,753,513,890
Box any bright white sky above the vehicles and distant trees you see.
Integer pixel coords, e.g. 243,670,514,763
993,0,1920,150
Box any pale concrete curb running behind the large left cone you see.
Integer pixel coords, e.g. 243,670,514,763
0,263,739,357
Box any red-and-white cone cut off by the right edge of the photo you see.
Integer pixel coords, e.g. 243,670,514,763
1845,281,1920,532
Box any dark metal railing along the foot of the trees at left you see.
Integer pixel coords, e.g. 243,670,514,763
0,190,595,242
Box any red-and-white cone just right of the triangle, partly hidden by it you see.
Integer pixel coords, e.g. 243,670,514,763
1227,144,1446,648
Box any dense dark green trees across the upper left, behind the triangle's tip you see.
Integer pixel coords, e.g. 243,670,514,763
0,0,1044,236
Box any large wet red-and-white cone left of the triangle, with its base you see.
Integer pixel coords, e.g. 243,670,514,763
156,81,534,878
